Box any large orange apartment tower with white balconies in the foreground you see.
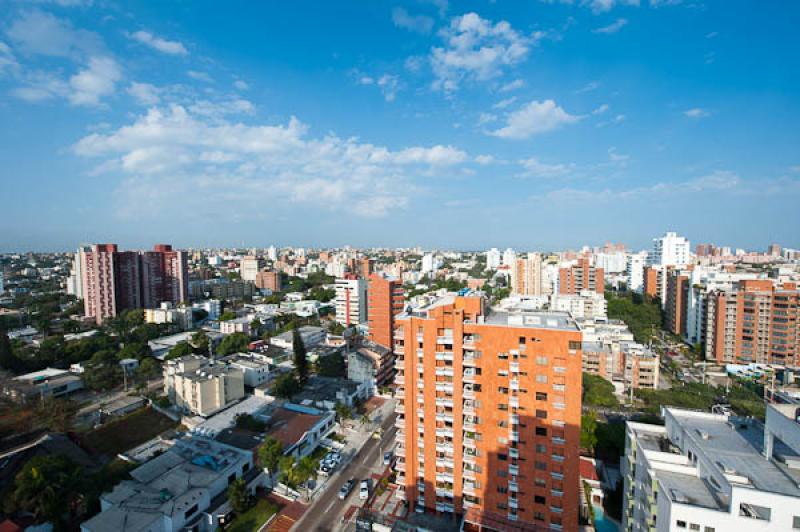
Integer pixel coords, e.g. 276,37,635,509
394,295,582,531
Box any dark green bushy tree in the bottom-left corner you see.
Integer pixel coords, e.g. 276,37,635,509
11,454,81,524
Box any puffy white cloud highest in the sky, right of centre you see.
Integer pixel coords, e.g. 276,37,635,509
430,13,535,92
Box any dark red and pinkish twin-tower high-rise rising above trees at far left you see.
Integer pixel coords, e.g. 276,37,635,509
79,244,189,324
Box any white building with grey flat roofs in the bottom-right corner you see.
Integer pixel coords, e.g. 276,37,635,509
621,404,800,532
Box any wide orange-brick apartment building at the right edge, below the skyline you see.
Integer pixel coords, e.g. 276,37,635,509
706,279,800,366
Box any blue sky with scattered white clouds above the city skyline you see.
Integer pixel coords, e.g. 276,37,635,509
0,0,800,254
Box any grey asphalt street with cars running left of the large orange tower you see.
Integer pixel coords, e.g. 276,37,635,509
293,412,397,532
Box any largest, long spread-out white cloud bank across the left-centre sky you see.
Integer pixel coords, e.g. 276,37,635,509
74,105,471,217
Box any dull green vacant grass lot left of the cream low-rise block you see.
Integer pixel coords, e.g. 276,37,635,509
82,408,178,456
